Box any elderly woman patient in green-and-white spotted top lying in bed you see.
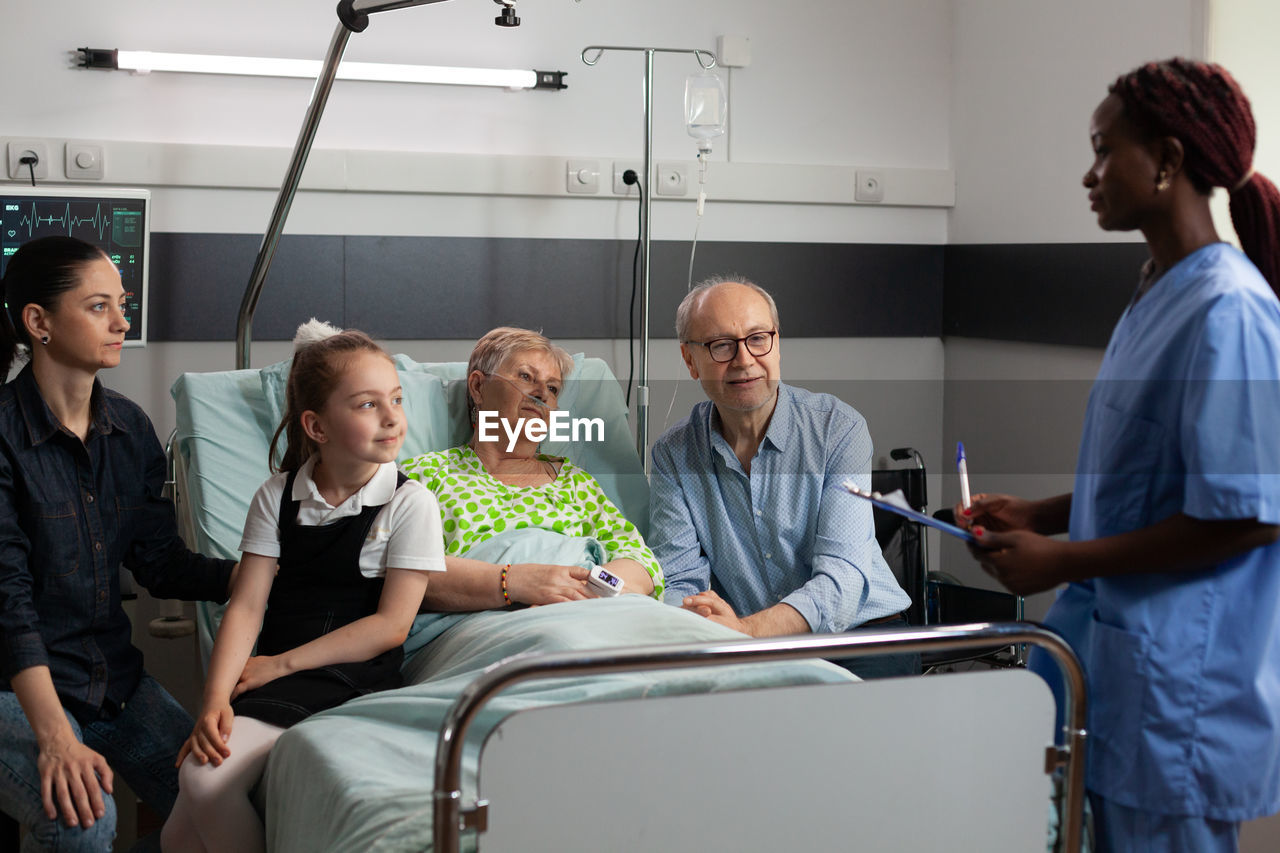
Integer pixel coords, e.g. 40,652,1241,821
404,327,663,611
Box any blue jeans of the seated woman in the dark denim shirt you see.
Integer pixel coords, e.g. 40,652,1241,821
0,675,195,853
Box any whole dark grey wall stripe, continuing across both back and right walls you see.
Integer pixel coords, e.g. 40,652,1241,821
148,233,1147,347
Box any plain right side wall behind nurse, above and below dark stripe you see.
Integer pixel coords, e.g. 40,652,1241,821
942,0,1204,604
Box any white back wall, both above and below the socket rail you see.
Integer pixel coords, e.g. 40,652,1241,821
0,0,951,432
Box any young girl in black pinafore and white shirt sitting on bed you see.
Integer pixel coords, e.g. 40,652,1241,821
161,320,444,853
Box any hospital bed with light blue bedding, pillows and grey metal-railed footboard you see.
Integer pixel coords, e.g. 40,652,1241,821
173,356,1085,852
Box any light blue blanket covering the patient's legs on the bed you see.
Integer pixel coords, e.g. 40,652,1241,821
265,596,852,853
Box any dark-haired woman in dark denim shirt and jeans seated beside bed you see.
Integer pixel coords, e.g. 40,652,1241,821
0,237,234,850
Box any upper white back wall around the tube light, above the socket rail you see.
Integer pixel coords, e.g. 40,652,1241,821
5,0,950,167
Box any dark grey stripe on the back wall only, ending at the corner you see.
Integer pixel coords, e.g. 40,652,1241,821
148,232,943,341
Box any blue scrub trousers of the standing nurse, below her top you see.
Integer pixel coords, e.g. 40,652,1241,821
1089,792,1240,853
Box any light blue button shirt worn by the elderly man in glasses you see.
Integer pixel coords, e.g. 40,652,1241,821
649,383,911,633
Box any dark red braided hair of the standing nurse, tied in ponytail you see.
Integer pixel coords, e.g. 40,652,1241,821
1108,59,1280,293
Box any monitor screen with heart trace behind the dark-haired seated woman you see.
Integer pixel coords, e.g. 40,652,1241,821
0,186,151,346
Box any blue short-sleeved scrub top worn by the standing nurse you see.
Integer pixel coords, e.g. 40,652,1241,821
1033,243,1280,821
